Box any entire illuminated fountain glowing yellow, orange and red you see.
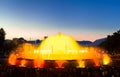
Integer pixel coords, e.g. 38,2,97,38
8,33,110,68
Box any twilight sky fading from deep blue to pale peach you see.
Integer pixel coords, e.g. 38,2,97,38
0,0,120,41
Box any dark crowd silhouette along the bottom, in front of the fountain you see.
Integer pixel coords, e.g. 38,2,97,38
0,61,120,77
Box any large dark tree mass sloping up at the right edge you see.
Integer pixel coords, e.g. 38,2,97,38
100,30,120,53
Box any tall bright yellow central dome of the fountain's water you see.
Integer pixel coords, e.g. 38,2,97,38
38,33,80,60
